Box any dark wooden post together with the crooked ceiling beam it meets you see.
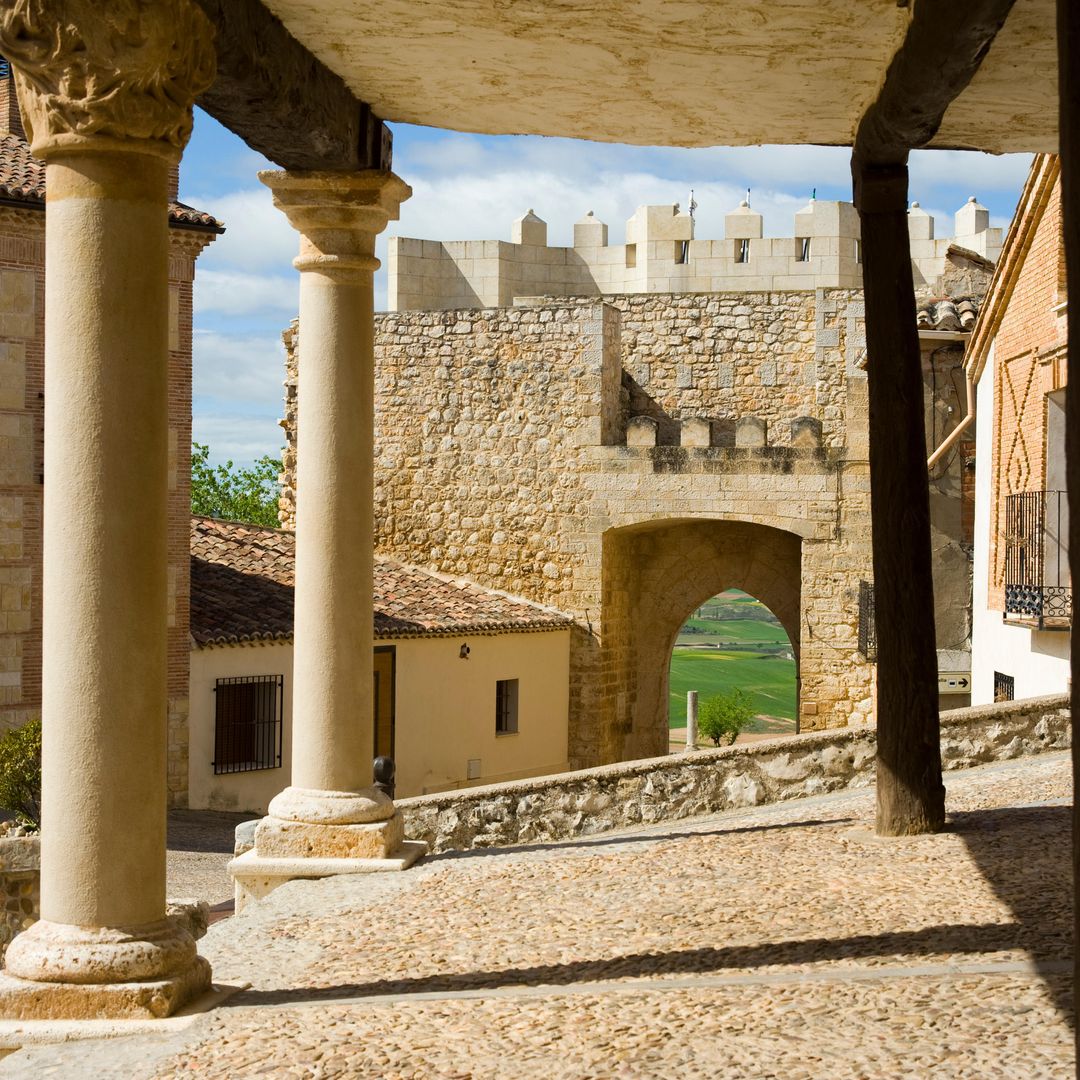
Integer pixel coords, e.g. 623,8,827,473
851,0,1013,836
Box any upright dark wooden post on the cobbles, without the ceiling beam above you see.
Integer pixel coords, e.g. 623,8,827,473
851,153,945,836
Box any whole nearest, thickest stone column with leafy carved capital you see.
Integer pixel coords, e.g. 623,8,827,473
0,0,214,1017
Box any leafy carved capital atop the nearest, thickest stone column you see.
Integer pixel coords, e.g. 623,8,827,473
0,0,216,158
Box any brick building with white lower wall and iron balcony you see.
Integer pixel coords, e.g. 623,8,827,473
967,154,1072,704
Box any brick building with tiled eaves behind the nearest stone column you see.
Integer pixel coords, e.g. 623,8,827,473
0,59,222,802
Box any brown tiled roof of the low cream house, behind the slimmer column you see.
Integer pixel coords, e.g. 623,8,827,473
191,517,572,645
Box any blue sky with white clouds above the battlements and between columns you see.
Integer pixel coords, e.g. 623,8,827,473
180,109,1030,463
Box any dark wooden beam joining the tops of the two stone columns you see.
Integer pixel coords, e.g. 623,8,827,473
195,0,392,172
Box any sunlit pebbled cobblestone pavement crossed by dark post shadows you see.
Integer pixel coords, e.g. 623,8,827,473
6,754,1072,1080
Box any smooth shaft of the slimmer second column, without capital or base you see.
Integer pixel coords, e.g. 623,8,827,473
293,267,375,792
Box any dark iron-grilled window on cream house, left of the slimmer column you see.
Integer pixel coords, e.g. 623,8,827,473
212,675,285,774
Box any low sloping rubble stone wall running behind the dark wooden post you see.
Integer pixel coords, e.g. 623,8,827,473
397,694,1071,851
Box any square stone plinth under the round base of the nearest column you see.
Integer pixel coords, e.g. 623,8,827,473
0,956,211,1020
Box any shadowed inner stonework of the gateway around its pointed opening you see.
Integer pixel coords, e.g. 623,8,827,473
603,519,802,758
